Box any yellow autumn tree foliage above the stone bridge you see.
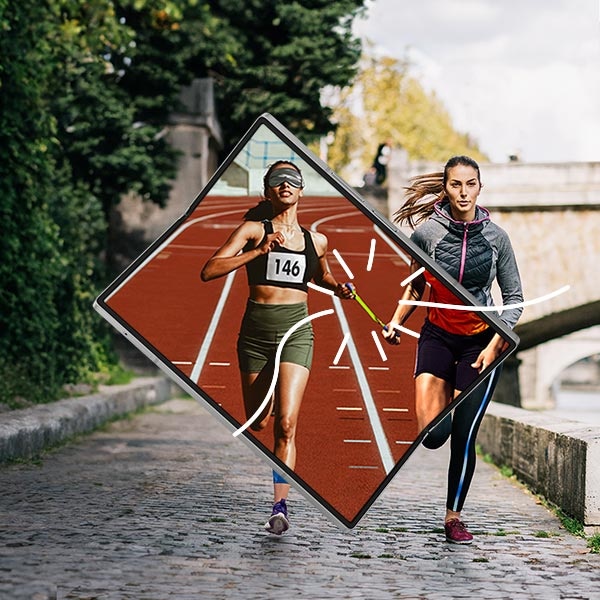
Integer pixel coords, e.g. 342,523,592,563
330,55,485,180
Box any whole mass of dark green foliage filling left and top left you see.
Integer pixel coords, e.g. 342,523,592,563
0,0,364,401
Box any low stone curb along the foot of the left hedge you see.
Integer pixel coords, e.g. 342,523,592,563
0,377,171,463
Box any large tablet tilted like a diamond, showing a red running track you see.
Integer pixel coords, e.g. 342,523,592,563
94,114,518,529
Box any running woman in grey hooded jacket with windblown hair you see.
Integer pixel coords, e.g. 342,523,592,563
382,156,523,544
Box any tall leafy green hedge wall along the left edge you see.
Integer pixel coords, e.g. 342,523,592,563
0,0,127,403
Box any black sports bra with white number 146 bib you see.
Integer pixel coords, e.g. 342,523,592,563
244,220,319,292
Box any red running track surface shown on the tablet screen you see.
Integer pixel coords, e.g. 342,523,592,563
108,196,424,520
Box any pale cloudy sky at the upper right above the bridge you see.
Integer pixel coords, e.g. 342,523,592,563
355,0,600,162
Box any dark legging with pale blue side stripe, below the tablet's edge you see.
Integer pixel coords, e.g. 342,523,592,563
423,367,501,512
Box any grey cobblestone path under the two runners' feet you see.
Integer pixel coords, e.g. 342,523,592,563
0,399,600,600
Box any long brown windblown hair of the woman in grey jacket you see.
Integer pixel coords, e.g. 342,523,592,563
393,156,481,229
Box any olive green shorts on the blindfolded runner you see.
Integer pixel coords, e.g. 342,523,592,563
237,299,314,373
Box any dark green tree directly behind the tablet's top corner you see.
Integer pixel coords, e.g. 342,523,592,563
190,0,364,146
